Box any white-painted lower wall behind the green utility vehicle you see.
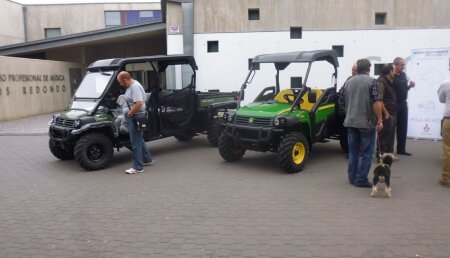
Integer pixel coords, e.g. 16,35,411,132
192,29,450,101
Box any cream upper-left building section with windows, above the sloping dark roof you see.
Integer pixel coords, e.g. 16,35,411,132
0,0,162,46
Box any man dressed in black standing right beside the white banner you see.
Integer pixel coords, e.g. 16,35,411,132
393,57,416,156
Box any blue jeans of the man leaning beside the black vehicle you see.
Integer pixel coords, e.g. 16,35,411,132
126,116,153,170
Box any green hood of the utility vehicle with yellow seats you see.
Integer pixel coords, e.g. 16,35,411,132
236,102,292,118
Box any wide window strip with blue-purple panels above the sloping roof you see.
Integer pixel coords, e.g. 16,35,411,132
105,10,161,28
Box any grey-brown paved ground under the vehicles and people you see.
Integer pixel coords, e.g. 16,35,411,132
0,117,450,258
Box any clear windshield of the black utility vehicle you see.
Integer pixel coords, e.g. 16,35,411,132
75,71,113,99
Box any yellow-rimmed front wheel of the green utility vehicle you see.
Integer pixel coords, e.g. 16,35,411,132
278,133,309,173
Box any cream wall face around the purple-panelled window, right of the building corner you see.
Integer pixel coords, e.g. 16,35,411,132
26,3,161,41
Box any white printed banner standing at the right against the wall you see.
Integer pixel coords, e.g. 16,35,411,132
406,47,450,139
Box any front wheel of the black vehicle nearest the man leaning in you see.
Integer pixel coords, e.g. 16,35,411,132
75,133,114,171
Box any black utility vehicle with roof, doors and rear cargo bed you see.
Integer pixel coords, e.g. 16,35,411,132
49,55,237,170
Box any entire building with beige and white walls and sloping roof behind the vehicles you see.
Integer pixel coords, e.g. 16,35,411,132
0,0,450,120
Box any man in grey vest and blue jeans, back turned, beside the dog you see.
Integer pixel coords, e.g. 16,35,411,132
344,59,383,187
